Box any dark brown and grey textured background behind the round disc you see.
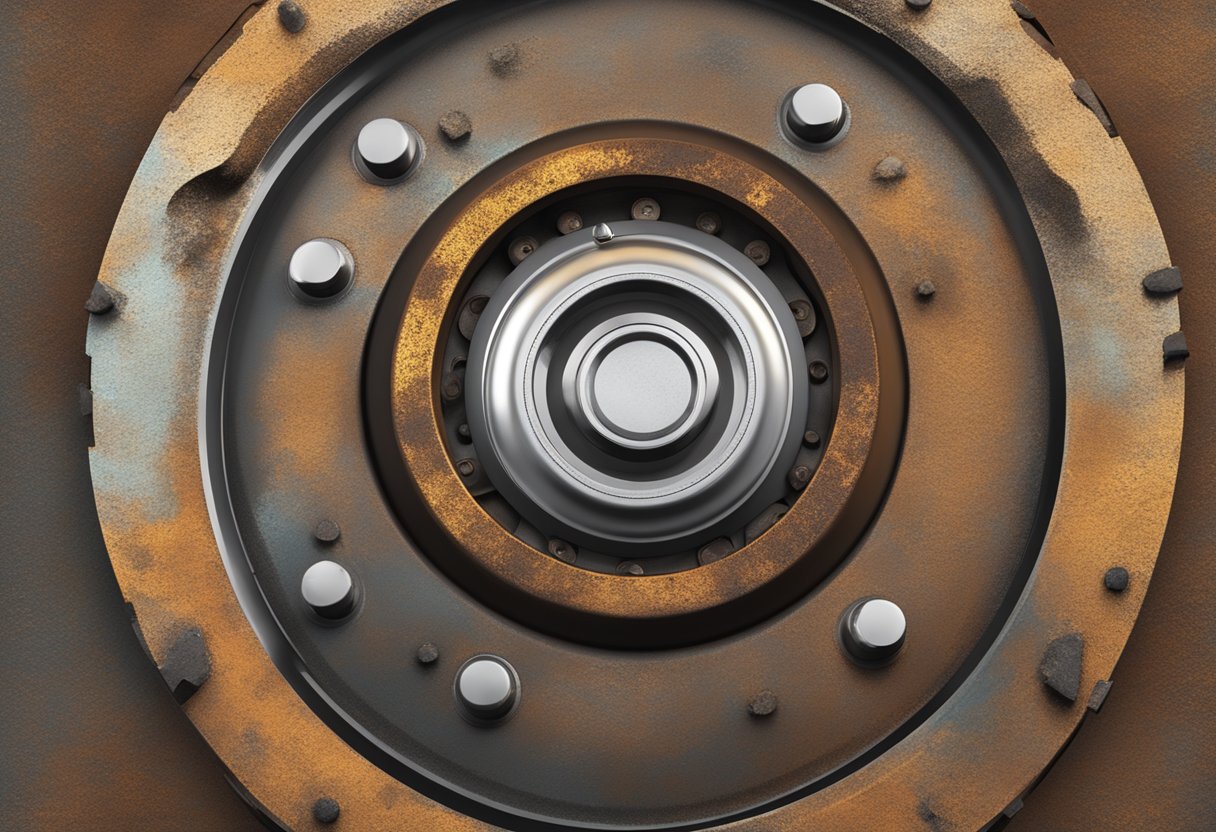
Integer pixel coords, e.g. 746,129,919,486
0,0,1216,831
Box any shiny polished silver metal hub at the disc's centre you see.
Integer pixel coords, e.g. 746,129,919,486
467,220,807,557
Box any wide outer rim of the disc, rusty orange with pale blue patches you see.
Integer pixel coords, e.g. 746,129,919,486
80,2,1182,830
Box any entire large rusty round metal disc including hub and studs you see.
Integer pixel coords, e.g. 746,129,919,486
89,0,1186,830
